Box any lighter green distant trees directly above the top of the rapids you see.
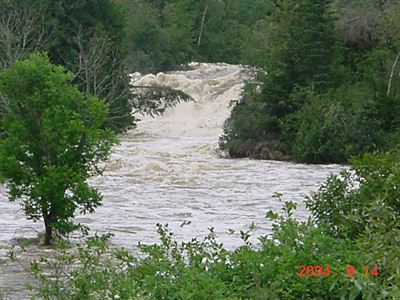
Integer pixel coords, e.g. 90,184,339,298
119,0,274,73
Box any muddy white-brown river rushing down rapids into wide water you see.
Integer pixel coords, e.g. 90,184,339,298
0,63,341,298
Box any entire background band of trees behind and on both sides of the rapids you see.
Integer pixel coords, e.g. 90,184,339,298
0,0,400,163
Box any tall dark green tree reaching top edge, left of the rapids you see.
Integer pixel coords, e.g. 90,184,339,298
42,0,135,132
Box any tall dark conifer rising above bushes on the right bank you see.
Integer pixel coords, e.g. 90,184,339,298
260,0,340,118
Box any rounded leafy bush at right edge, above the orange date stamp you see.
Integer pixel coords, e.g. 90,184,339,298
307,153,400,238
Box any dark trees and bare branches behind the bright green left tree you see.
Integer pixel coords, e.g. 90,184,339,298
0,0,134,132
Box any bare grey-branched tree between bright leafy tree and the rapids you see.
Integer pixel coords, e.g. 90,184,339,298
65,28,135,132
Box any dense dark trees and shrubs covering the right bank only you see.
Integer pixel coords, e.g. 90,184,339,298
220,0,400,163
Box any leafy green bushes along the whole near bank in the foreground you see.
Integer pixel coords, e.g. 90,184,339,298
10,149,400,300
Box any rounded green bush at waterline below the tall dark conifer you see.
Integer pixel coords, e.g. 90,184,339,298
283,84,383,163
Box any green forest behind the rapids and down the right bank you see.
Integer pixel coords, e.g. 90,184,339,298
115,0,400,163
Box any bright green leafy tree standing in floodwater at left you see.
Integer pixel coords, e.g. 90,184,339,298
0,54,116,244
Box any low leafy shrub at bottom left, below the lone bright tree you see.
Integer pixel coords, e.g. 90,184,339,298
32,235,145,300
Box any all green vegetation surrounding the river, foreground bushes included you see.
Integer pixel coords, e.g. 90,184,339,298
0,0,400,300
